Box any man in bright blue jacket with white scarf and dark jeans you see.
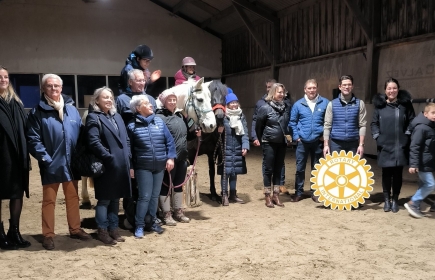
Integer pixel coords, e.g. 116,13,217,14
289,79,329,203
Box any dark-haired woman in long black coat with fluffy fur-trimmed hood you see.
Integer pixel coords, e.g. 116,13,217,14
371,78,415,213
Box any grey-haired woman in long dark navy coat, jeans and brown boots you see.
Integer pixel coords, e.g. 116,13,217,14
86,87,131,245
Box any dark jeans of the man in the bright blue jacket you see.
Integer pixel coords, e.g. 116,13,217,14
295,141,323,196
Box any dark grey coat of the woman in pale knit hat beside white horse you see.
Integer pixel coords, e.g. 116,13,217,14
156,108,187,161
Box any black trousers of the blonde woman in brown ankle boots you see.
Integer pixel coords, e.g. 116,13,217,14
262,142,287,187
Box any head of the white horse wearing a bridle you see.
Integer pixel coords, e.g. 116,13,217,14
185,78,216,133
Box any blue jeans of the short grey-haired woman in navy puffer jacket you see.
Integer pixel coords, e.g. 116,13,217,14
134,169,164,227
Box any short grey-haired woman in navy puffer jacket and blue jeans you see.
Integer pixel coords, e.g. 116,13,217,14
127,95,177,238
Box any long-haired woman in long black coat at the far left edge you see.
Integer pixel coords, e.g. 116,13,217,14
0,66,30,250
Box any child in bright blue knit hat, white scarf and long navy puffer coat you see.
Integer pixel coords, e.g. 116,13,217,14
218,88,249,206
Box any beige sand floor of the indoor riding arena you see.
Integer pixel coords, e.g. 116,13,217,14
0,149,435,279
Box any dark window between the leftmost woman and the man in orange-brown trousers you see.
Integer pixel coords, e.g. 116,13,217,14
9,74,41,108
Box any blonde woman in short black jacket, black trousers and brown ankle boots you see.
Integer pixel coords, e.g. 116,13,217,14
255,83,291,208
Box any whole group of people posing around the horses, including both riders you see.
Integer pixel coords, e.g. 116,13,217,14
0,45,435,250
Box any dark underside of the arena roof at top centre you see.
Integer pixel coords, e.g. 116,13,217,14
150,0,310,37
